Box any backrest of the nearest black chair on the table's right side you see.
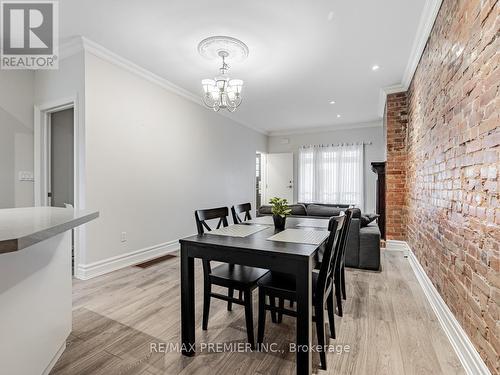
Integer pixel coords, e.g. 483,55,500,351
316,213,346,298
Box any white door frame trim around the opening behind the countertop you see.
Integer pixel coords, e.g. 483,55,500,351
34,94,85,277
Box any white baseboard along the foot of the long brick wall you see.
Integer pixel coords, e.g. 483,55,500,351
404,241,491,375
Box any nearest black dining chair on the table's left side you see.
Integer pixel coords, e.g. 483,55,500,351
195,207,269,348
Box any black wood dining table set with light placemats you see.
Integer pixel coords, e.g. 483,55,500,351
179,217,328,375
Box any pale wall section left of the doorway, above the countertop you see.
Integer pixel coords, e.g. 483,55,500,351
0,70,34,208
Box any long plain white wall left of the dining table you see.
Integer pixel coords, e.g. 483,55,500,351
85,52,267,264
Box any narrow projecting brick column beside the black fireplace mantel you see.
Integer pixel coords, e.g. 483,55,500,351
385,93,408,240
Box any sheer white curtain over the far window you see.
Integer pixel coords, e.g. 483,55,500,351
298,144,364,211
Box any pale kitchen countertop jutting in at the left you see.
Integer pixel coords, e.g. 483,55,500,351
0,207,99,254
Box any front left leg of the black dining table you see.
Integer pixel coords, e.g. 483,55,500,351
181,245,195,356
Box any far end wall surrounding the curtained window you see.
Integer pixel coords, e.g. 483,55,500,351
268,122,385,212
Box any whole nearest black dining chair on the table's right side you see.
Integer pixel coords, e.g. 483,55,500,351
257,215,346,370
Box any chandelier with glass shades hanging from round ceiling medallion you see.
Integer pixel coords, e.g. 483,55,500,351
198,36,248,112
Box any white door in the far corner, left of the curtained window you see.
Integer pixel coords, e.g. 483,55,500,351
266,153,294,203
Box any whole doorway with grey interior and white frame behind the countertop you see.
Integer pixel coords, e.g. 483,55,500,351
34,95,85,278
